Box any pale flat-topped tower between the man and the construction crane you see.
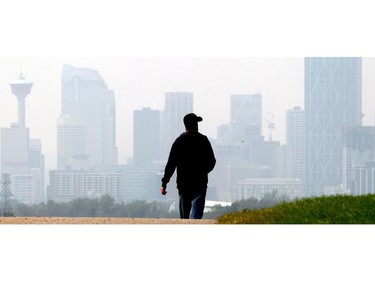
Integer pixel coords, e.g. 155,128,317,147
230,94,262,144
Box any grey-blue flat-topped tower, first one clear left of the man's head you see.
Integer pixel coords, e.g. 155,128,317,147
133,107,160,164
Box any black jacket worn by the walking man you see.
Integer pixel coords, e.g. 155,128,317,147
161,132,216,190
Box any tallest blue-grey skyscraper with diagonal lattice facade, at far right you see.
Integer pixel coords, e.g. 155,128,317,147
305,57,362,196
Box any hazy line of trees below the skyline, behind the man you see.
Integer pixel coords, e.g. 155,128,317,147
5,191,290,219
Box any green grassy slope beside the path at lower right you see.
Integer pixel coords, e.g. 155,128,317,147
218,194,375,224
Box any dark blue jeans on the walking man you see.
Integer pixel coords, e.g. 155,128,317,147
178,186,207,219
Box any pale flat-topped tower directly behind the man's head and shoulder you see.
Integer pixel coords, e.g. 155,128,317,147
163,92,193,160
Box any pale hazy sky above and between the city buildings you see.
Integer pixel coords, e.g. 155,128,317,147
0,58,375,172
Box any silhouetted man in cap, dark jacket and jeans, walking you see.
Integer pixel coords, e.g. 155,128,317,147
160,113,216,219
